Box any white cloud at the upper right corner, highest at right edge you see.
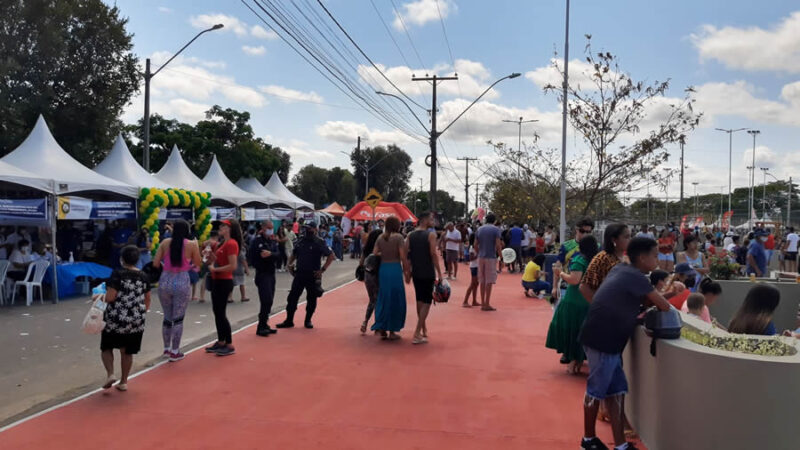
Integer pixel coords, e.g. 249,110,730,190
691,11,800,73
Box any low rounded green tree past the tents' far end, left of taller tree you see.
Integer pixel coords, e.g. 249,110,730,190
289,164,355,208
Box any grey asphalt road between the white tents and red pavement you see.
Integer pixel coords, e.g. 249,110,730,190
0,258,357,427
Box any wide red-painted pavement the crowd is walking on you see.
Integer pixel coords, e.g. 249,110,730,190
0,265,636,450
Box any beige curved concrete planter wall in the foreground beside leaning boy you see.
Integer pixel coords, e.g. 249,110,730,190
623,327,800,450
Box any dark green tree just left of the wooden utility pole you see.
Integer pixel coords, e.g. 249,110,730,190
350,145,411,202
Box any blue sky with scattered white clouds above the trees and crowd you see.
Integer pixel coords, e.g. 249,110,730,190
108,0,800,206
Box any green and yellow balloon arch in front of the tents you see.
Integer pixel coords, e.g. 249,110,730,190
139,188,211,255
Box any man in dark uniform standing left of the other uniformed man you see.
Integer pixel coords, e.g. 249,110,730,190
248,220,280,337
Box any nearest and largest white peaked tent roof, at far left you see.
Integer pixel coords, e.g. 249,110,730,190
1,115,139,198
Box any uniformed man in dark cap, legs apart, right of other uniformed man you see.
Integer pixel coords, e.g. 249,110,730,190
276,222,335,328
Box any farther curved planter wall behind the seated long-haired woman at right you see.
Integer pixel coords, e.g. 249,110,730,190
708,280,800,330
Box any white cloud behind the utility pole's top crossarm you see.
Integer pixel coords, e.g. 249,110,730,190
358,59,500,100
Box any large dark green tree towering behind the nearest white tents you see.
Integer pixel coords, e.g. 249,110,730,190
0,0,141,167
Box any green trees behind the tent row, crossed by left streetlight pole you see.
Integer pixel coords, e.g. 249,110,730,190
126,105,291,183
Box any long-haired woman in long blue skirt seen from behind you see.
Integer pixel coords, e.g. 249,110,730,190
372,217,411,340
